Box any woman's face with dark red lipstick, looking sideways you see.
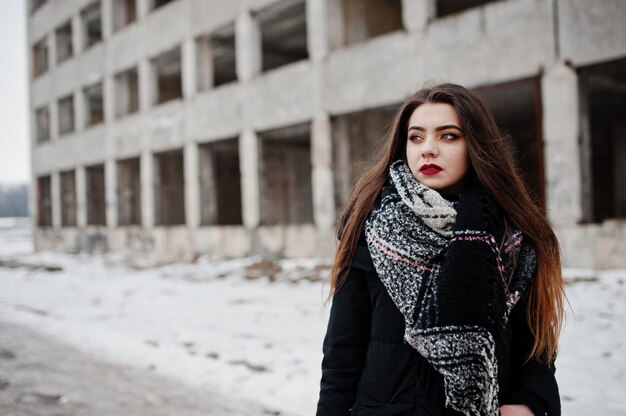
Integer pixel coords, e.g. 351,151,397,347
406,103,470,195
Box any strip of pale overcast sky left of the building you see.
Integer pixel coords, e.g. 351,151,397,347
0,0,30,184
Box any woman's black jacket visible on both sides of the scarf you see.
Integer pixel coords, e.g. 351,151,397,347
317,238,560,416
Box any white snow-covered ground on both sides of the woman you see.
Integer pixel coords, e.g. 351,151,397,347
0,219,626,416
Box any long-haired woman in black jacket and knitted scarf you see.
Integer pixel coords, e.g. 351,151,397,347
317,84,563,416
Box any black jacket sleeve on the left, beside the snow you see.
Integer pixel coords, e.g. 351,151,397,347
317,263,371,416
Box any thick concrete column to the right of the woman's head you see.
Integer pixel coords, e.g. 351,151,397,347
541,62,582,226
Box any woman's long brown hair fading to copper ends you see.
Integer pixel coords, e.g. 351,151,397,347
330,83,564,362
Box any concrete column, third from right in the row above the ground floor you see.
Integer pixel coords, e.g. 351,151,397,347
235,10,262,82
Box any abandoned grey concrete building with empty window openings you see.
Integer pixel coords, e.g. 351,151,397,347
28,0,626,268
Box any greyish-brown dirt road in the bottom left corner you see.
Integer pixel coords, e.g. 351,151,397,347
0,320,279,416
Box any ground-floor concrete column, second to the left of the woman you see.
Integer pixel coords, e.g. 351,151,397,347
239,129,261,228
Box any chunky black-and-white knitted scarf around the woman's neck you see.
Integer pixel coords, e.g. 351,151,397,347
365,161,535,416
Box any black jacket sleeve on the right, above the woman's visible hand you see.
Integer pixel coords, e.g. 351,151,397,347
504,297,561,416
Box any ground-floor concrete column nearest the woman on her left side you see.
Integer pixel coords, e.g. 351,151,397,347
311,114,335,256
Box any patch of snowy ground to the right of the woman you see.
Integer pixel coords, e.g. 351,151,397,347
556,270,626,416
